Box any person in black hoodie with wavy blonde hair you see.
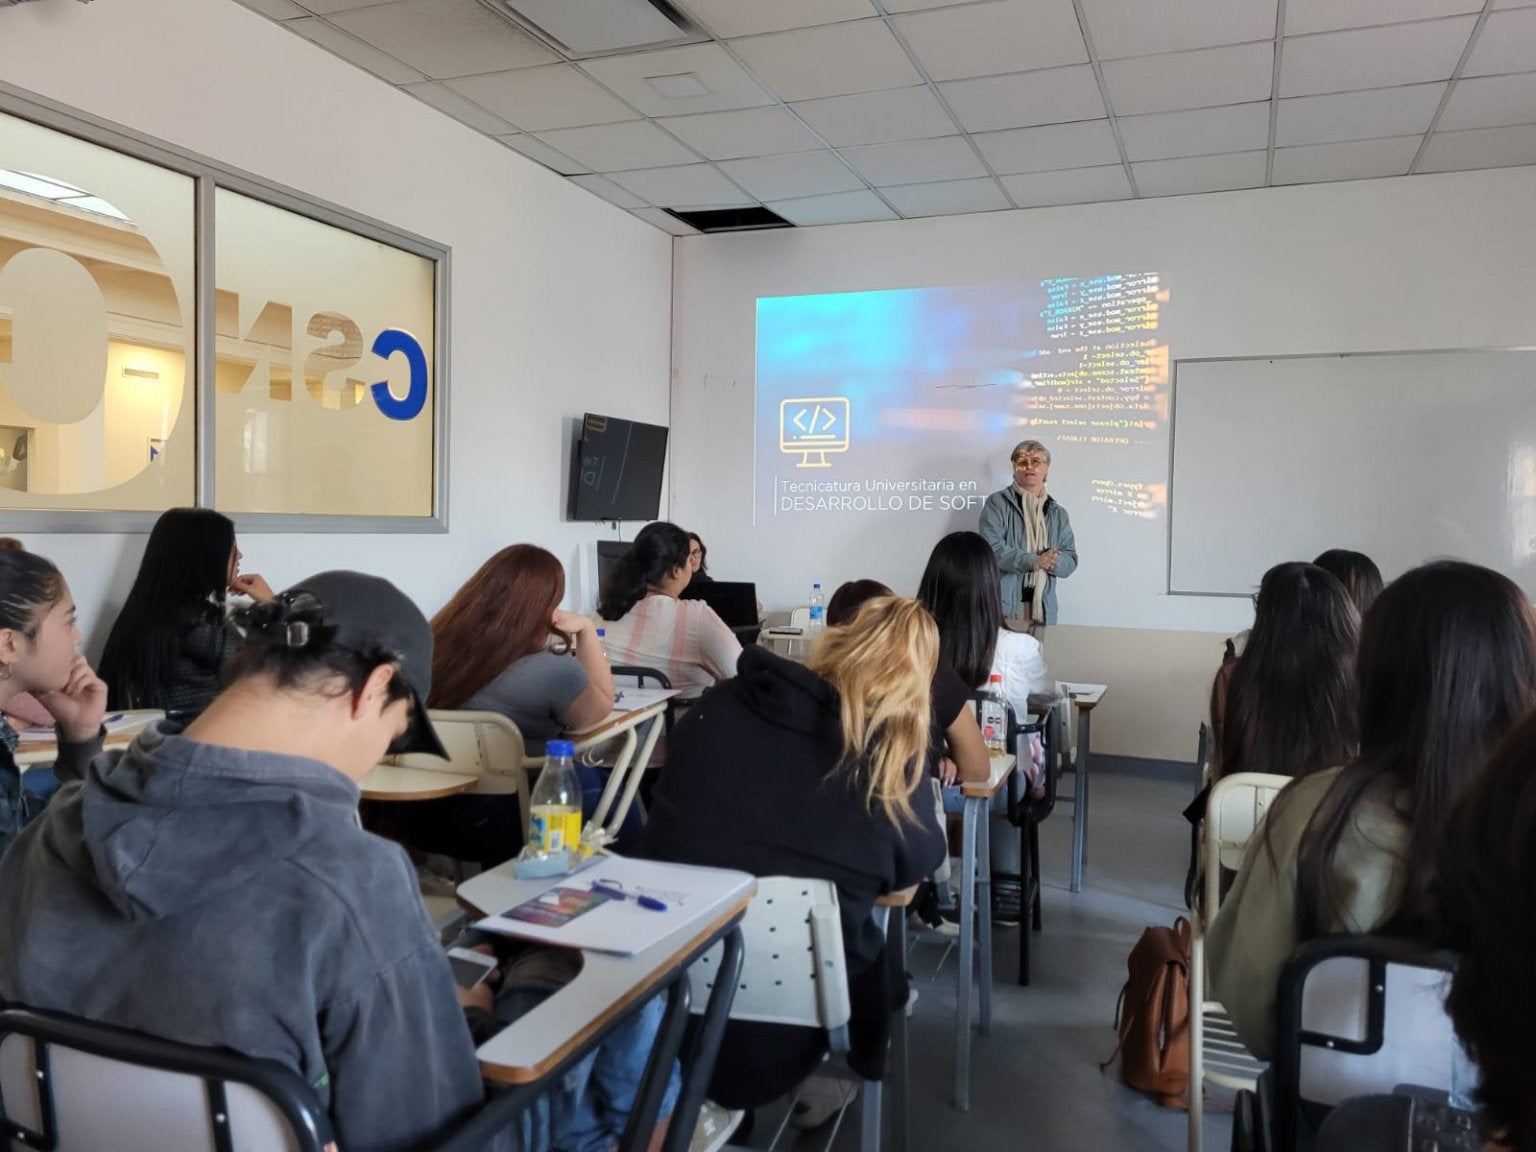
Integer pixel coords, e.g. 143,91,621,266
641,596,945,1124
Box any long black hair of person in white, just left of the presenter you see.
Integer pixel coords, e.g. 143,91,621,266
917,531,1003,688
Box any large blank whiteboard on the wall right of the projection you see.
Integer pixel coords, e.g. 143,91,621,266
1169,350,1536,596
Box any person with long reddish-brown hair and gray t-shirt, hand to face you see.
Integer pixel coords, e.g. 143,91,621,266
392,544,613,868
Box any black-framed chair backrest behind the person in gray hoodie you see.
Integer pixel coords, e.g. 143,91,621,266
0,1008,330,1152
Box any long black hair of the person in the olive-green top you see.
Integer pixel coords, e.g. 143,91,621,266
1290,561,1536,938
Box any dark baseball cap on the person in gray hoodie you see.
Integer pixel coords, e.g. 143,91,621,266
283,570,449,760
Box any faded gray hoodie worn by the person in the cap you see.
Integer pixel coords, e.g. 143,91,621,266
0,723,509,1152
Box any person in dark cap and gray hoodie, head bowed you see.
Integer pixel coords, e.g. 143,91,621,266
0,571,503,1152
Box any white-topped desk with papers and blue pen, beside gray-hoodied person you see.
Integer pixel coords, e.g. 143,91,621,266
458,862,757,1152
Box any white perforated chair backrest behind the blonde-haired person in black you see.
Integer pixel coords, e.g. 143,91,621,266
688,876,851,1048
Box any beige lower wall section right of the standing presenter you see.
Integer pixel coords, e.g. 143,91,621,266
1044,625,1227,765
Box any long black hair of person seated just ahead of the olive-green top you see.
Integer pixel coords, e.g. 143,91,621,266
1212,562,1359,792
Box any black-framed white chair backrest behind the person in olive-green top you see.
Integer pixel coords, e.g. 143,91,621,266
1275,935,1456,1152
